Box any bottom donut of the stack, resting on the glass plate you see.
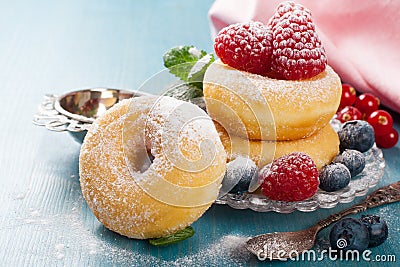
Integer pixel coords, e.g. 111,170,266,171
215,123,339,169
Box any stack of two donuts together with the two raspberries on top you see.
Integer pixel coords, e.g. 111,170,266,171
204,2,341,168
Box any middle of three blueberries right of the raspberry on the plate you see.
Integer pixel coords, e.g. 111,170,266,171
333,149,365,177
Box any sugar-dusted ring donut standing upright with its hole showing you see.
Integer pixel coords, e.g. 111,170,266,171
79,96,226,239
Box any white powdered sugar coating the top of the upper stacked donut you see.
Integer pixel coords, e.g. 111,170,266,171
204,61,340,108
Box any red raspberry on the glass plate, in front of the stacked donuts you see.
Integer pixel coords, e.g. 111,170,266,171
260,152,319,201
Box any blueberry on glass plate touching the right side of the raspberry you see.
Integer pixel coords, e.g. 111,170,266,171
319,163,351,192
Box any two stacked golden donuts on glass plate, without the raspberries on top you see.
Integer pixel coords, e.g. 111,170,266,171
204,61,341,168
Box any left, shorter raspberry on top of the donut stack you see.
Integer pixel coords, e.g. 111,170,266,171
214,21,272,76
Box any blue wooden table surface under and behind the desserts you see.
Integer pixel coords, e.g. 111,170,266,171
0,0,400,266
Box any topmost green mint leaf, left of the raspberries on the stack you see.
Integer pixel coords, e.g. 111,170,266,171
163,46,214,89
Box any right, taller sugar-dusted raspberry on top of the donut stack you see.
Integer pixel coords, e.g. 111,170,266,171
268,2,327,80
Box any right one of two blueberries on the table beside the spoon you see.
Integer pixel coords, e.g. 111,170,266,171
360,215,388,247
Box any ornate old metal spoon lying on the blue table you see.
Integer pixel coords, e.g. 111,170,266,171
245,181,400,260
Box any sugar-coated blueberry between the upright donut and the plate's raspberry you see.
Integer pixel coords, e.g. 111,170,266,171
220,157,258,196
